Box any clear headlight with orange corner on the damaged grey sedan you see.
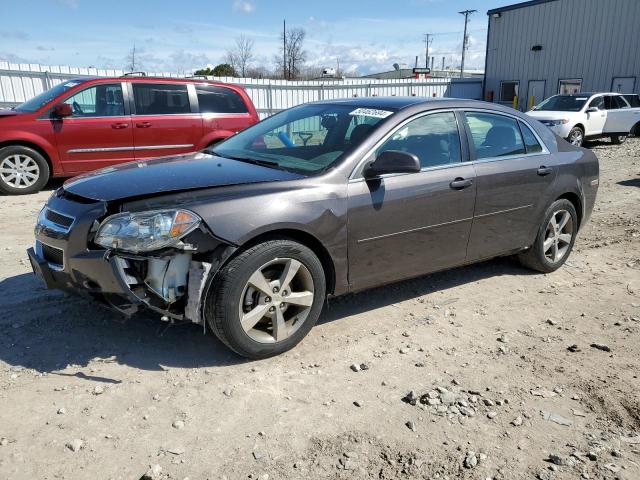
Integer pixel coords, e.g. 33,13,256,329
94,210,200,253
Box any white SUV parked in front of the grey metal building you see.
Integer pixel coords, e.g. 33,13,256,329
527,93,640,146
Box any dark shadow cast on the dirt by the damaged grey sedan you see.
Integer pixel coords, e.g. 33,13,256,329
0,259,528,374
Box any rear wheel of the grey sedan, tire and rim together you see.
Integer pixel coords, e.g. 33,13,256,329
518,199,578,273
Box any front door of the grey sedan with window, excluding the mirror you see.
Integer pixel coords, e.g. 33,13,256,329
348,112,476,290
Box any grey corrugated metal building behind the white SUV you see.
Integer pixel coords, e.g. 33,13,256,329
484,0,640,110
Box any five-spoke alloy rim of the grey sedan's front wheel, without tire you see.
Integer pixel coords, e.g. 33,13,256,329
238,258,314,343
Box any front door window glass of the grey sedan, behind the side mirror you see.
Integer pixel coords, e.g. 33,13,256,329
376,112,461,168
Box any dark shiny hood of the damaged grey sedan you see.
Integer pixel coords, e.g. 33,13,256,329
63,153,303,202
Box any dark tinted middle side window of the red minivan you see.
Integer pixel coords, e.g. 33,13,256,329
133,83,191,115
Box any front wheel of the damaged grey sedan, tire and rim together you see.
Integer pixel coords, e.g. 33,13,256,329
204,239,326,359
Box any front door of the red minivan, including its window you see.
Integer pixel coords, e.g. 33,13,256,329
51,82,134,175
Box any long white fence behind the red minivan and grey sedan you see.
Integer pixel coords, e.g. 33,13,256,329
0,62,482,118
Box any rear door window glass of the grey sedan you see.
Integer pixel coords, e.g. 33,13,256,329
465,112,525,159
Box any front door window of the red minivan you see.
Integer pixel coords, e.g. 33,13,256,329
64,83,124,118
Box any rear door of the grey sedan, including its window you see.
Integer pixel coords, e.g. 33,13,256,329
465,111,556,261
